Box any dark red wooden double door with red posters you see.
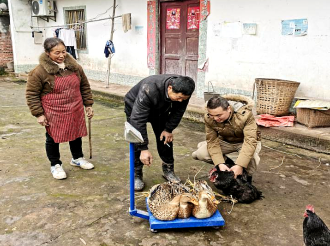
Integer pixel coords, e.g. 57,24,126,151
160,0,200,81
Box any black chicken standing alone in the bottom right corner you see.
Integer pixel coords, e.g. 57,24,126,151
303,205,330,246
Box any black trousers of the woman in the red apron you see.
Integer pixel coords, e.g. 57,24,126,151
46,132,84,166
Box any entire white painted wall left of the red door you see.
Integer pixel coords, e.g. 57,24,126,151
9,0,149,77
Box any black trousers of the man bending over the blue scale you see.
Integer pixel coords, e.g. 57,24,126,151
127,117,174,170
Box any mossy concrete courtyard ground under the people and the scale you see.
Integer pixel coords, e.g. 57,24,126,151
0,78,330,246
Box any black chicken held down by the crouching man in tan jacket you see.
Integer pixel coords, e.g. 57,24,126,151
209,157,263,203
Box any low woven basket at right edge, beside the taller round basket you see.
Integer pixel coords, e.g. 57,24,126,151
297,108,330,127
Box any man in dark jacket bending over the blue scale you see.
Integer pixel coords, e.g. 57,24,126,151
125,74,195,191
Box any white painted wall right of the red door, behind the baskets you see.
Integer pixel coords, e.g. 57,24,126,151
206,0,330,99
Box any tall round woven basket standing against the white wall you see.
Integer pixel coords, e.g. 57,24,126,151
255,78,300,116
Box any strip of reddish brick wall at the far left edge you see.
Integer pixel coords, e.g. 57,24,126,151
0,16,13,67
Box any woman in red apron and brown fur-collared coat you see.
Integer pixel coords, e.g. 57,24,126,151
26,38,94,179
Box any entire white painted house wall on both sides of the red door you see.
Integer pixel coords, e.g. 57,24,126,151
9,0,330,99
